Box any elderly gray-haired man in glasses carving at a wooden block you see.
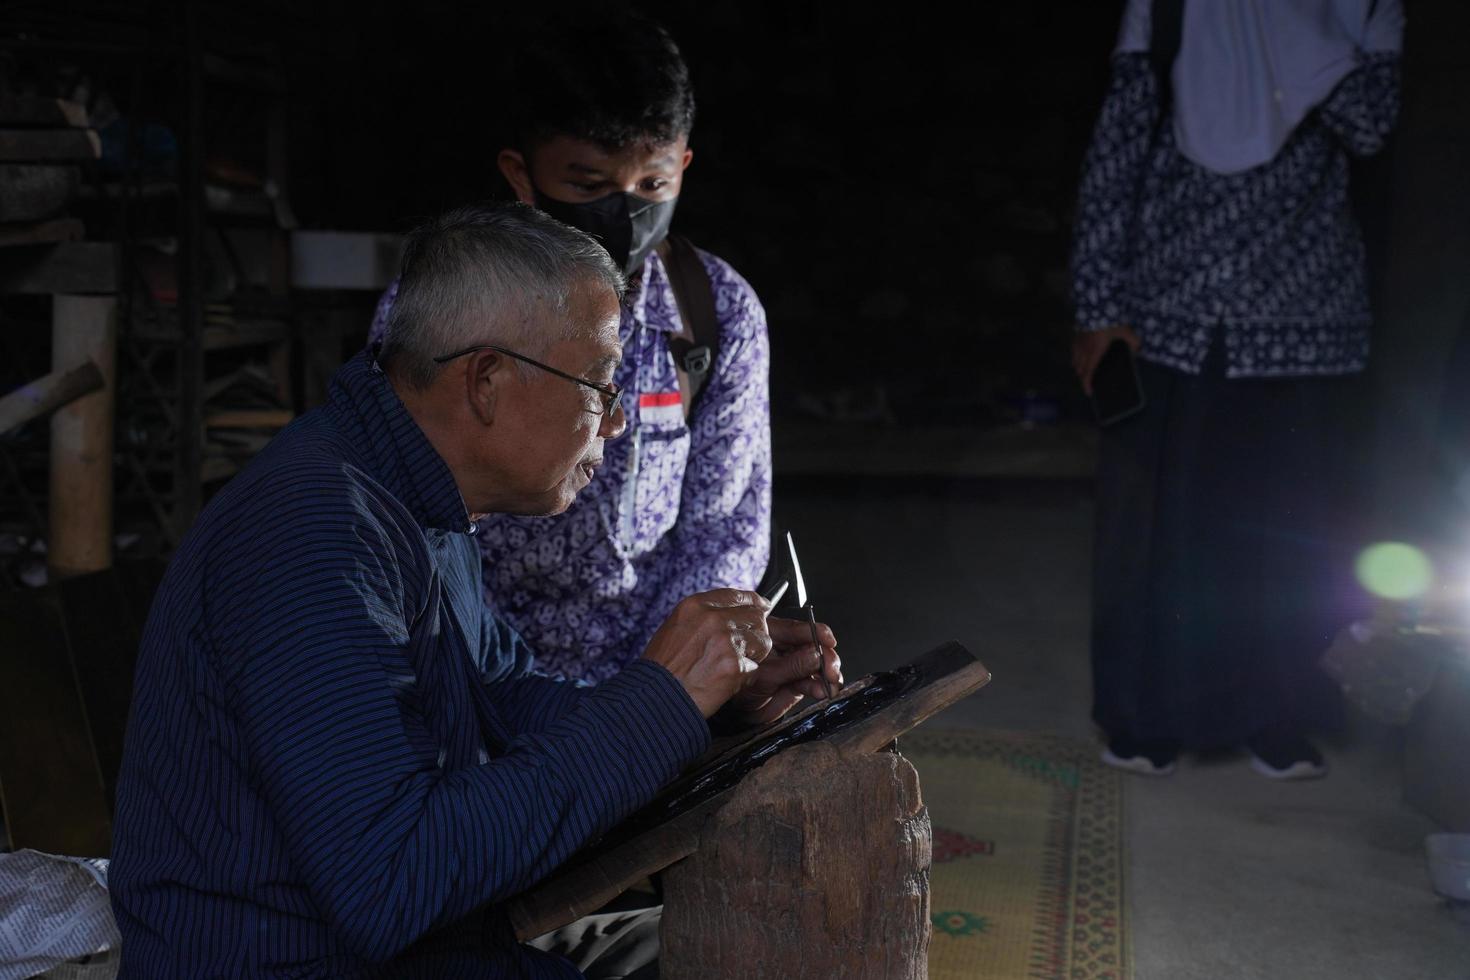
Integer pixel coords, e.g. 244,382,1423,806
112,204,839,979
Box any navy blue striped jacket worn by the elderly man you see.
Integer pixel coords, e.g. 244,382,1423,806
110,353,709,980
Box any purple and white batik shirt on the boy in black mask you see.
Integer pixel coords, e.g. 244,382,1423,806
370,251,770,682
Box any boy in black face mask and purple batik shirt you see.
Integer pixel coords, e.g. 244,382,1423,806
373,10,770,682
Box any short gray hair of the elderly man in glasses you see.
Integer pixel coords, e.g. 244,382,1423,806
381,203,626,389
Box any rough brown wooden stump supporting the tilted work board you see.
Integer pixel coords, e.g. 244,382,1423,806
659,742,932,980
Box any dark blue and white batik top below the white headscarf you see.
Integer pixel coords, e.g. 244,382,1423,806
1072,54,1399,378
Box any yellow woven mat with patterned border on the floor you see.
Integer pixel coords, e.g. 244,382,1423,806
898,729,1132,980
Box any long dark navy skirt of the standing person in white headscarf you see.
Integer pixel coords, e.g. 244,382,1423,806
1092,351,1361,748
